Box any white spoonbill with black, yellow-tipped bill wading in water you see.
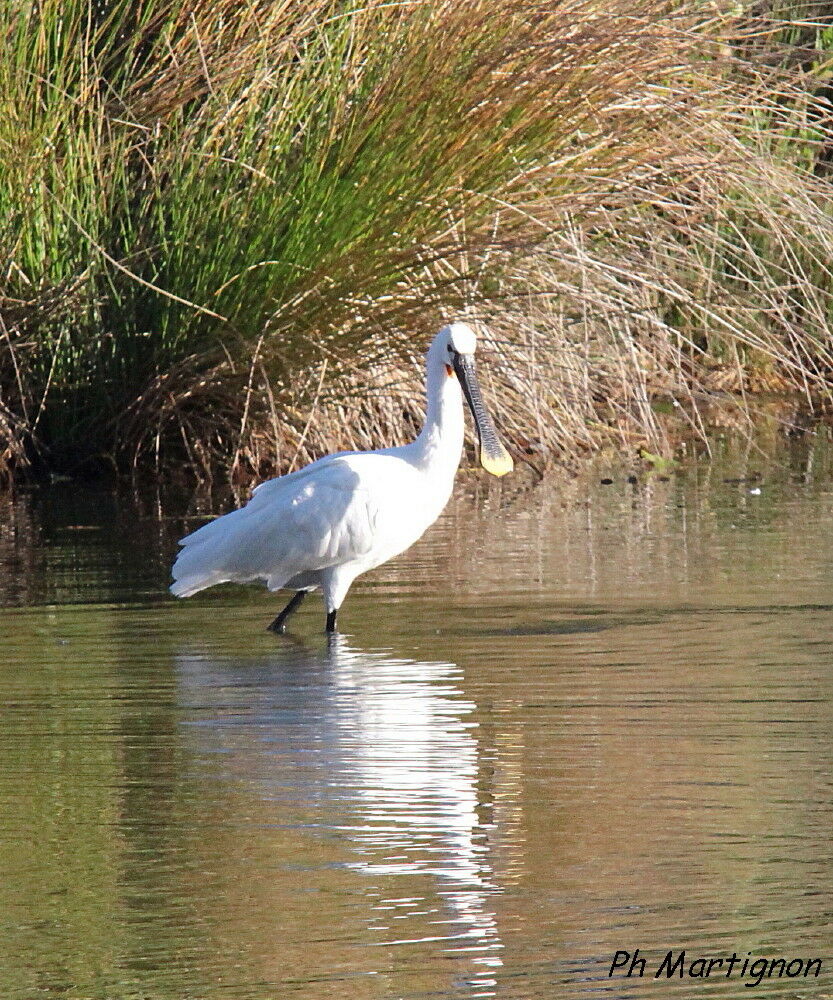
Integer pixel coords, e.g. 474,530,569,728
170,322,513,635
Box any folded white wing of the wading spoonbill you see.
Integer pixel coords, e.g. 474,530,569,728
172,456,378,596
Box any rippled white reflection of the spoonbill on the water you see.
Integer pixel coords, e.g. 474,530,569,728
178,636,502,996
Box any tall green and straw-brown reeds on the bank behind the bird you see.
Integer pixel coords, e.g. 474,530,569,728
0,0,833,476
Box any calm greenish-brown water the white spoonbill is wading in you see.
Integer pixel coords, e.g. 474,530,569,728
0,432,833,1000
